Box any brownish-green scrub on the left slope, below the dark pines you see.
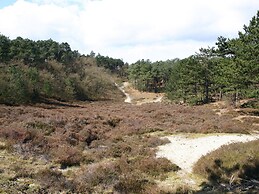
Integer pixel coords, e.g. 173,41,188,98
0,60,122,105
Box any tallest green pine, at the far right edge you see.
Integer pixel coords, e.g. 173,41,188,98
216,11,259,102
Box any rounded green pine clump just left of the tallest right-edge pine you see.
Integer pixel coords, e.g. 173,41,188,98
167,50,219,104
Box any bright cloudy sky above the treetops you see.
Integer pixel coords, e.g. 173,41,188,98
0,0,259,63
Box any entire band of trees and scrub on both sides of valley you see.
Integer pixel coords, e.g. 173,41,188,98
0,11,259,104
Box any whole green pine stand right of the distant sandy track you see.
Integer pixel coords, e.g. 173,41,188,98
129,11,259,104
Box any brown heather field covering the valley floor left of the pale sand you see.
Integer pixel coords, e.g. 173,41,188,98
0,102,258,193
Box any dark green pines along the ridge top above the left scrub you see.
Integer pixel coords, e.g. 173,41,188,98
0,35,80,66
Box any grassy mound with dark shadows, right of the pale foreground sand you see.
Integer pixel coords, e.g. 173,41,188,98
194,140,259,193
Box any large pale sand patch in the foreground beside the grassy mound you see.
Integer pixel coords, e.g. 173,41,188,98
157,134,259,173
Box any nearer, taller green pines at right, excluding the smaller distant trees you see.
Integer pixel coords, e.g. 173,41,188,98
167,11,259,104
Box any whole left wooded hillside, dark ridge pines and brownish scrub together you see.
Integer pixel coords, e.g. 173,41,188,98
0,35,127,104
